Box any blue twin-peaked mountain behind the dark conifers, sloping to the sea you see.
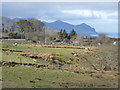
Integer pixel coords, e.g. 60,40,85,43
44,20,98,36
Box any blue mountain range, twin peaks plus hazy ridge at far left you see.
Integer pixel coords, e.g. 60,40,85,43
1,17,98,36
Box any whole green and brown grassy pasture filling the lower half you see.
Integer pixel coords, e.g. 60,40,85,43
2,42,119,88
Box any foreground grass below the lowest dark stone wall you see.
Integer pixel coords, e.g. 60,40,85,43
3,66,117,88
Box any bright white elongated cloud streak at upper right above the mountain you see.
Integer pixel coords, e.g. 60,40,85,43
61,9,118,19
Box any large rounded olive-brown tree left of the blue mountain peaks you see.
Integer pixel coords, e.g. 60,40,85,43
17,19,45,42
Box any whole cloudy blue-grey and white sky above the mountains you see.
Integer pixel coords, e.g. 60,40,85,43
2,2,118,32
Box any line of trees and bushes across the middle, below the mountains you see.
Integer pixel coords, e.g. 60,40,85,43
2,19,110,44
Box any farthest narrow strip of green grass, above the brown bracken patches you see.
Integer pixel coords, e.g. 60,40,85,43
3,43,82,57
